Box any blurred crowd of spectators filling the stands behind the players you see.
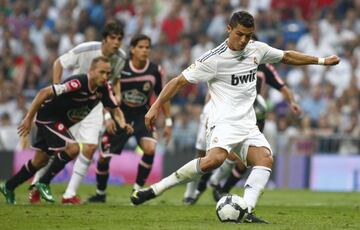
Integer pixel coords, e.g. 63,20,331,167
0,0,360,154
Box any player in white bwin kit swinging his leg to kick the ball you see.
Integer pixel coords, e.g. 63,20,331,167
131,11,340,223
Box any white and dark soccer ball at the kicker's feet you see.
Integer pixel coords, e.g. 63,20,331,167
216,194,247,223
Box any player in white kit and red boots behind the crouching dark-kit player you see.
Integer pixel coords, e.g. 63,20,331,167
29,22,132,204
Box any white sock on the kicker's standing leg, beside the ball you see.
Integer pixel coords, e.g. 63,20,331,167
244,166,271,212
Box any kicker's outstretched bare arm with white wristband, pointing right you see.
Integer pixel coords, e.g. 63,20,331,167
281,50,340,65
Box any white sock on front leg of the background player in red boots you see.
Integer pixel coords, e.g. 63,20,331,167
63,153,91,199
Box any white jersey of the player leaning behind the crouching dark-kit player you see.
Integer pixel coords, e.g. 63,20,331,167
60,41,126,81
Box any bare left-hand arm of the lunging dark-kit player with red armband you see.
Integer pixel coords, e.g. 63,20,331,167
18,86,55,136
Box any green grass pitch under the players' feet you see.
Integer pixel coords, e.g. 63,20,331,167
0,184,360,230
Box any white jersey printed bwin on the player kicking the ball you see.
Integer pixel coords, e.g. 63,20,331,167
182,40,284,130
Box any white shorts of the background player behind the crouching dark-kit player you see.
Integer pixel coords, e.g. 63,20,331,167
70,102,104,145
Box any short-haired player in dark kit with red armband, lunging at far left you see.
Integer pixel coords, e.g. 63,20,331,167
0,56,131,204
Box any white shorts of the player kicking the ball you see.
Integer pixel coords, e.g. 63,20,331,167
206,125,272,166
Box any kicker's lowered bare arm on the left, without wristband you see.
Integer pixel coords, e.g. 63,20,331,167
145,74,189,130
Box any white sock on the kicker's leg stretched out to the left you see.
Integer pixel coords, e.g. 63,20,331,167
151,158,203,196
